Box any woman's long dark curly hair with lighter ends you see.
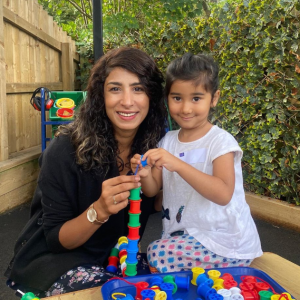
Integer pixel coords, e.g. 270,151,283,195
58,47,167,173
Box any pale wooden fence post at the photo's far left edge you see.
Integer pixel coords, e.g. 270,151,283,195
0,2,8,161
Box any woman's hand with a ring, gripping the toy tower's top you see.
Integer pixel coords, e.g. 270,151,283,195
94,175,141,220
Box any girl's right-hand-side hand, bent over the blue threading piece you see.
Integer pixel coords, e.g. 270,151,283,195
143,148,181,172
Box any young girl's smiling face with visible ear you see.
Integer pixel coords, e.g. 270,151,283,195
168,80,220,135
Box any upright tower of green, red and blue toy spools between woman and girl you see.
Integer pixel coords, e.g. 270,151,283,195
125,187,142,276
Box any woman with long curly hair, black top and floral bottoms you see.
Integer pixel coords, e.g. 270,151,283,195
5,47,166,296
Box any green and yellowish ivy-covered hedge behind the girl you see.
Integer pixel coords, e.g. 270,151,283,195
140,0,300,205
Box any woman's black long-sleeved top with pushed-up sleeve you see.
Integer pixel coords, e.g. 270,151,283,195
5,135,153,291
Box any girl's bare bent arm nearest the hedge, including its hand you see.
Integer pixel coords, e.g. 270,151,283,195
144,148,235,205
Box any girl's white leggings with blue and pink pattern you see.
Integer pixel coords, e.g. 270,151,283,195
147,234,252,273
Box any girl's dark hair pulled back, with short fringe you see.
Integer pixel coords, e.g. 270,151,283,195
165,53,219,96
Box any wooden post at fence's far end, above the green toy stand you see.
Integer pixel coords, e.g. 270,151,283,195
61,43,74,91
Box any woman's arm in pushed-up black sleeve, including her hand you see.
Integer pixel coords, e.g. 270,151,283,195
39,136,140,253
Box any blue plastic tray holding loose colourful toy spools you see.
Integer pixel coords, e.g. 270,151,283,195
101,267,293,300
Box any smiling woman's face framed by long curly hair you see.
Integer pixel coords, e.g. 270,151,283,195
104,67,149,136
